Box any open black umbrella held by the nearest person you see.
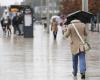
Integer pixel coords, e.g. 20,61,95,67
65,11,94,24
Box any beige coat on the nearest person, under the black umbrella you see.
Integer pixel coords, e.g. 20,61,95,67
64,20,87,55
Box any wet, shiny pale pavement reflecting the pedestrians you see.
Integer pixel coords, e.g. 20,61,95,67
0,24,100,80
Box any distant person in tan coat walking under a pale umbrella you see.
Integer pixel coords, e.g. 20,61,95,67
51,18,58,39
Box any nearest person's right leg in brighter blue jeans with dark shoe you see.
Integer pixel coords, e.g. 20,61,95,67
79,52,86,79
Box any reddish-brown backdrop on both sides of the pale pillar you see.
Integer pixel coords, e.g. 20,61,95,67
60,0,100,14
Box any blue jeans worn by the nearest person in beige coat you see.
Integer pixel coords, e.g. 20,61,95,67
73,52,86,76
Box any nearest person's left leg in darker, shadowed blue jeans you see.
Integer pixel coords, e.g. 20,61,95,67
72,54,78,76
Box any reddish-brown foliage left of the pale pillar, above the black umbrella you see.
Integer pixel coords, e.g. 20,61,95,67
60,0,81,14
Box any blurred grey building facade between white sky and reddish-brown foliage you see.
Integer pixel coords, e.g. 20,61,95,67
23,0,60,16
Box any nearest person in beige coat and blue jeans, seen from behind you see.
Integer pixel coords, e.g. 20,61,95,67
64,20,87,80
